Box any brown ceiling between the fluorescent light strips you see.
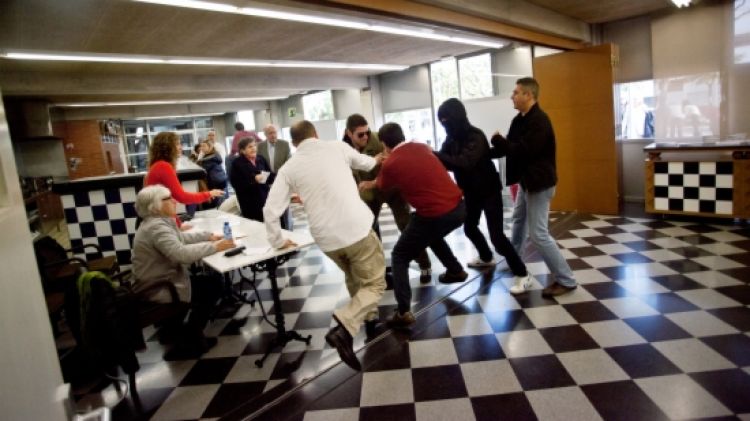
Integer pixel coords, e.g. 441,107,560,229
0,0,680,113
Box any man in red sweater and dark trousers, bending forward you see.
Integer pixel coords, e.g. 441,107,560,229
360,123,468,327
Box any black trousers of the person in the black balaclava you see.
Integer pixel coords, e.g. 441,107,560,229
464,190,527,276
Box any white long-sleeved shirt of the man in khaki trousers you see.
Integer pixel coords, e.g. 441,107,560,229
263,138,376,251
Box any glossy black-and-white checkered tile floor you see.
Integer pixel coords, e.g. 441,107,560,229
67,204,750,421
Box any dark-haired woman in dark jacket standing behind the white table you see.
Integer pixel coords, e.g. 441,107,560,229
230,138,271,222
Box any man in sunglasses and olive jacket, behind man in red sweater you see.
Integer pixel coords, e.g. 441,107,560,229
344,114,432,289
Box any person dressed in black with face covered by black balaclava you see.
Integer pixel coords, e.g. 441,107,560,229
435,98,531,293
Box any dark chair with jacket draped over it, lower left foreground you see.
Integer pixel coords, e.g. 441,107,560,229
65,270,189,405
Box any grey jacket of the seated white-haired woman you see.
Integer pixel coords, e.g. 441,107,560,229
132,217,216,302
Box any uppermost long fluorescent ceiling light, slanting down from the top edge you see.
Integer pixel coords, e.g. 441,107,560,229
133,0,506,48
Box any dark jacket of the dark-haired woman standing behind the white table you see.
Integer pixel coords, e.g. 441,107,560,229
230,154,271,222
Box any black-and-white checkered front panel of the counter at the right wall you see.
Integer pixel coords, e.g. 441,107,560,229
654,161,734,215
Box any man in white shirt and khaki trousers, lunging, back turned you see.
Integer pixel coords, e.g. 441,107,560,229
263,120,385,370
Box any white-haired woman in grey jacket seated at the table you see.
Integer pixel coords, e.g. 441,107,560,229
132,184,234,354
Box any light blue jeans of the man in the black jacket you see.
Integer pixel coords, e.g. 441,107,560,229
511,186,576,287
